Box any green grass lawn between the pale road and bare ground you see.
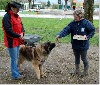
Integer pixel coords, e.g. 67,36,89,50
0,18,99,46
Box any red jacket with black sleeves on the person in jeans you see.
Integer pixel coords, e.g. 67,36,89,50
2,11,24,48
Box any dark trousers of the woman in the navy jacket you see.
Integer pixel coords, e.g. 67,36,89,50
73,49,88,68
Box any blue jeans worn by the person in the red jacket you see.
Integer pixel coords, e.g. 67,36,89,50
8,46,20,78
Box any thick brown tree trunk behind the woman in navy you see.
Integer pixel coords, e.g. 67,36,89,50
83,0,94,23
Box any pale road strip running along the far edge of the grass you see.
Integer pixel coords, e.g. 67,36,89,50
0,11,99,20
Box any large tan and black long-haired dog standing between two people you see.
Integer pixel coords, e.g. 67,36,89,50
18,41,56,79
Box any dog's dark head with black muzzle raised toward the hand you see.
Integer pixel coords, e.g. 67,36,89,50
41,41,56,55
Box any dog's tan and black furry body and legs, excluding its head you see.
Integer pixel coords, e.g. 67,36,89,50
18,42,55,79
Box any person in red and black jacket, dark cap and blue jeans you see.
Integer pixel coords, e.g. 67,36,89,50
2,1,25,79
